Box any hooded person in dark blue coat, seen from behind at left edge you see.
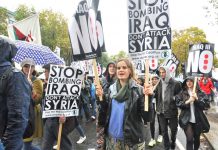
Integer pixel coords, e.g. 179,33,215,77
0,35,31,150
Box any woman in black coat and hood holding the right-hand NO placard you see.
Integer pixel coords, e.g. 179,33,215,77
176,77,209,150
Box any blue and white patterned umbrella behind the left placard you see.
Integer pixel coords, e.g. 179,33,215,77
13,41,64,65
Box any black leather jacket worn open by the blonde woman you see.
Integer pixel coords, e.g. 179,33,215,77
101,80,150,146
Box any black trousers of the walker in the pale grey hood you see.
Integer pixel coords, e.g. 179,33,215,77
159,113,178,150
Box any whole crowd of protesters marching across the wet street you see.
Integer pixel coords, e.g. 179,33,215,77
0,37,216,150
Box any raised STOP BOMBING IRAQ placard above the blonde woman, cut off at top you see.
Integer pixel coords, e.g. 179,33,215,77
128,0,171,60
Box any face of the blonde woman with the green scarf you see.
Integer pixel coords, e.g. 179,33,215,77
117,61,131,81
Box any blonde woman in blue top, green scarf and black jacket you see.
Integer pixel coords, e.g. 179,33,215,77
96,59,152,150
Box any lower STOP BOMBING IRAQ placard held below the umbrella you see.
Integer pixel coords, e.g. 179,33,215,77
42,65,84,118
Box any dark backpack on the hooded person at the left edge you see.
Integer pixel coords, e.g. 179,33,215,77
0,67,14,139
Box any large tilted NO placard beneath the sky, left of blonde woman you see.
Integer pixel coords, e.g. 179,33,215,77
68,0,105,61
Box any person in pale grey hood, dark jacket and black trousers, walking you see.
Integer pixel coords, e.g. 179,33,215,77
154,66,181,150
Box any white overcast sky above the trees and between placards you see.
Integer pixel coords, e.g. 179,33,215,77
0,0,218,55
